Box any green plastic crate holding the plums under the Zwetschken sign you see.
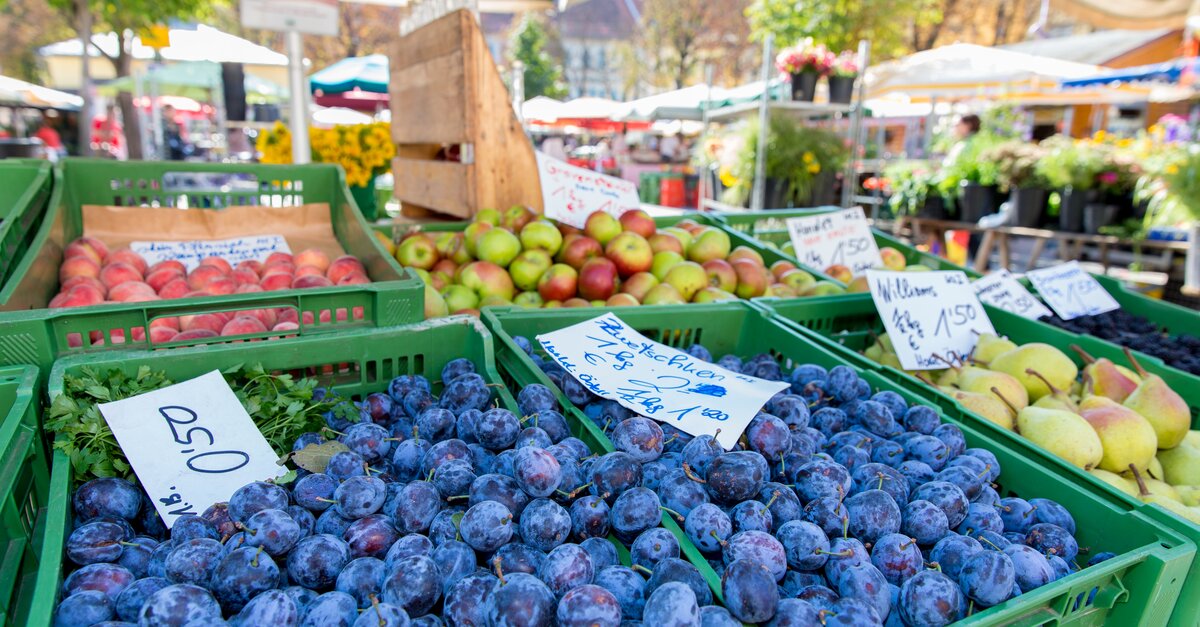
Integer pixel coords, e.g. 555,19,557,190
484,303,1195,627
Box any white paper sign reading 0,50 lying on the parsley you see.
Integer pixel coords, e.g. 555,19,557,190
98,370,287,529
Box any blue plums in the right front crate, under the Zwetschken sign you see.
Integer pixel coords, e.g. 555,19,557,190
512,329,1114,626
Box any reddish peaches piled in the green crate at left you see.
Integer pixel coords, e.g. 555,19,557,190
49,237,371,346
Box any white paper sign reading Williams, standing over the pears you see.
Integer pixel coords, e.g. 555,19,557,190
866,270,996,370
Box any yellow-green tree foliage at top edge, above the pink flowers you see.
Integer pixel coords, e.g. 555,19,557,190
746,0,936,59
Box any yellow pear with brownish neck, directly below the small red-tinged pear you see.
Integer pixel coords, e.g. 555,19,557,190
1079,396,1158,472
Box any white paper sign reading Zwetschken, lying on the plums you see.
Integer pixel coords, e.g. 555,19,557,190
538,314,788,450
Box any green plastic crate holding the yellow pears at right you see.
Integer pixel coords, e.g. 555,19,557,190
755,294,1200,626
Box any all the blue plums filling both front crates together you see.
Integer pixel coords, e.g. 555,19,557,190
54,340,1106,627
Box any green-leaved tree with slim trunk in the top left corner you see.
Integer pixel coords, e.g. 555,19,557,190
50,0,223,159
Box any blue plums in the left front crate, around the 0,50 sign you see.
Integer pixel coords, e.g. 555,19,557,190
54,358,728,627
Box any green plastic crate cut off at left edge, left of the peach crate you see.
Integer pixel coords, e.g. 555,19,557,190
0,160,54,285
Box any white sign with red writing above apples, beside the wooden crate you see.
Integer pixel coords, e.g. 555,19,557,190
538,153,641,228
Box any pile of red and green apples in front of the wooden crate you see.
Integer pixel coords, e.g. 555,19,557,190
395,207,842,317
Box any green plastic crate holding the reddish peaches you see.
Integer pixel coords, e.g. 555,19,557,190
0,160,425,375
